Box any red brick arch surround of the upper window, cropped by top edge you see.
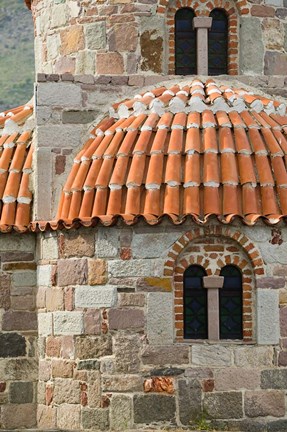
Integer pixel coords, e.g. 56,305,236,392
165,0,249,75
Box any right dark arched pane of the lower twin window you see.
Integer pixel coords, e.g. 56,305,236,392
219,265,243,339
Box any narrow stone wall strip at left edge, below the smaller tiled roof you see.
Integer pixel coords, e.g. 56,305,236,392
0,234,38,430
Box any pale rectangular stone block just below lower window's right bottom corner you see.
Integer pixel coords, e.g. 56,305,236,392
234,346,273,368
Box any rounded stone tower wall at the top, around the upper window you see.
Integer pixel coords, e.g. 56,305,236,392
32,0,287,75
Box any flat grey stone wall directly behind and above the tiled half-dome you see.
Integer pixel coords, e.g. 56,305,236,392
34,74,287,220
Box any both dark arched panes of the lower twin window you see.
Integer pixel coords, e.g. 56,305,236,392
184,265,243,339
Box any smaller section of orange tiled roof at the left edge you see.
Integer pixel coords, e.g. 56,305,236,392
0,104,33,232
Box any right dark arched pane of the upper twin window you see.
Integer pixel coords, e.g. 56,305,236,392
208,9,228,75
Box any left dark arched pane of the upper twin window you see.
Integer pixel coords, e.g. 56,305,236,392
175,8,196,75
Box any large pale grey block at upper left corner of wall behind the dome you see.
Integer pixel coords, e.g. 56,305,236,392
37,82,82,108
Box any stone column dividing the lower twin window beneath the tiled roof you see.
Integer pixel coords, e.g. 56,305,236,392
203,276,224,341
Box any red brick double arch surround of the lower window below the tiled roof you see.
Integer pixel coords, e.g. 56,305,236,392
164,226,265,342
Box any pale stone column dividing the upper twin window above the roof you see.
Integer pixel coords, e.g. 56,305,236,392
193,17,212,75
